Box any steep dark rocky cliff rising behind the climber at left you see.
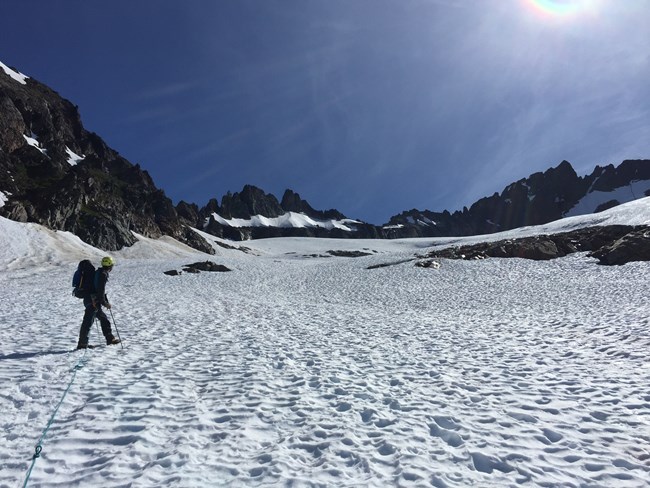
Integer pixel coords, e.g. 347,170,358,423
0,62,212,252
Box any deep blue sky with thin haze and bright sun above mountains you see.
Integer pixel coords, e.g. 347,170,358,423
0,0,650,224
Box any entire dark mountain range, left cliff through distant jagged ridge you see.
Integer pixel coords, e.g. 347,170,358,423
5,56,650,252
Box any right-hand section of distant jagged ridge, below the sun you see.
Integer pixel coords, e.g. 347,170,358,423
383,160,650,237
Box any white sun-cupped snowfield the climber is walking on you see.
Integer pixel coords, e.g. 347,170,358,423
0,198,650,487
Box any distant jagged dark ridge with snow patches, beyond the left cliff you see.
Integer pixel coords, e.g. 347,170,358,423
197,160,650,240
